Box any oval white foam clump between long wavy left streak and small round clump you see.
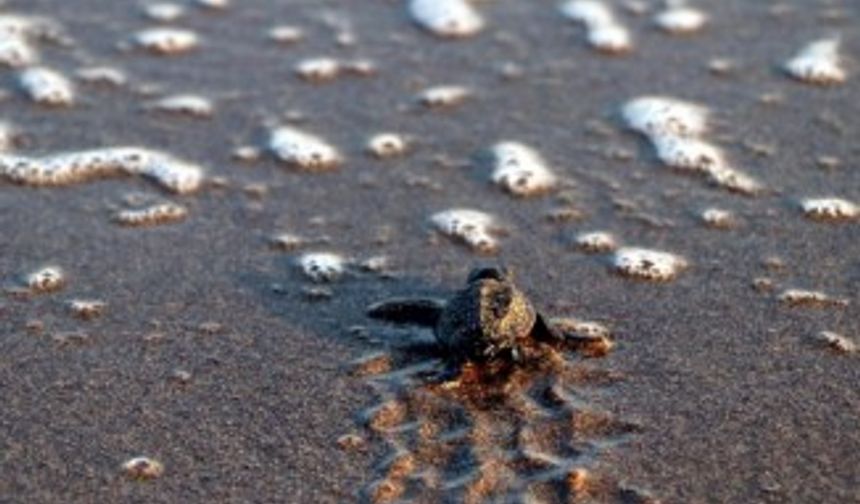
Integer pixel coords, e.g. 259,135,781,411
269,126,342,171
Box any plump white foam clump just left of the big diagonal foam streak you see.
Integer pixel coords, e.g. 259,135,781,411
491,142,557,196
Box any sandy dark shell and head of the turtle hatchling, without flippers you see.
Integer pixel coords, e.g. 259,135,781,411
435,268,536,361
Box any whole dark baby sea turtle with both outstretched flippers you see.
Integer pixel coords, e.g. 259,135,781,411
367,266,612,363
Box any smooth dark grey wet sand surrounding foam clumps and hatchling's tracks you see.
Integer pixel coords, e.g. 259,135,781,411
0,0,860,504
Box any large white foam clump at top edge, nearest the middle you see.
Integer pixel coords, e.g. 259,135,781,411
407,0,484,38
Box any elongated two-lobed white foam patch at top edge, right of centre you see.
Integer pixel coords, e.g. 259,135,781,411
560,0,633,53
